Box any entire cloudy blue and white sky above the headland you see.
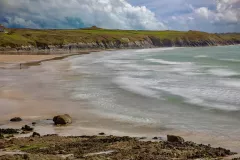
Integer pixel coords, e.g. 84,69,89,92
0,0,240,32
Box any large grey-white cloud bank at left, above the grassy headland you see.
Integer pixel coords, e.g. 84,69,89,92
0,0,167,30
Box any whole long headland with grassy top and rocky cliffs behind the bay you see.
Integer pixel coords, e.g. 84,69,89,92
0,29,240,51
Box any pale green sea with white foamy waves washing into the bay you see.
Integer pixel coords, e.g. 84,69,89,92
69,46,240,138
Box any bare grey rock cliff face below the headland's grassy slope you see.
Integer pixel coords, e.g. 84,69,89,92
32,36,240,50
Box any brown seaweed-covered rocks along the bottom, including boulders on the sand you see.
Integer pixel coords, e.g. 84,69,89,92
0,114,240,160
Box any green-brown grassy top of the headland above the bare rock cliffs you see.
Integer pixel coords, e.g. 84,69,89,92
0,28,240,48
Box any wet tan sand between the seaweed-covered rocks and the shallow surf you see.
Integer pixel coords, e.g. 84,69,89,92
0,51,240,153
